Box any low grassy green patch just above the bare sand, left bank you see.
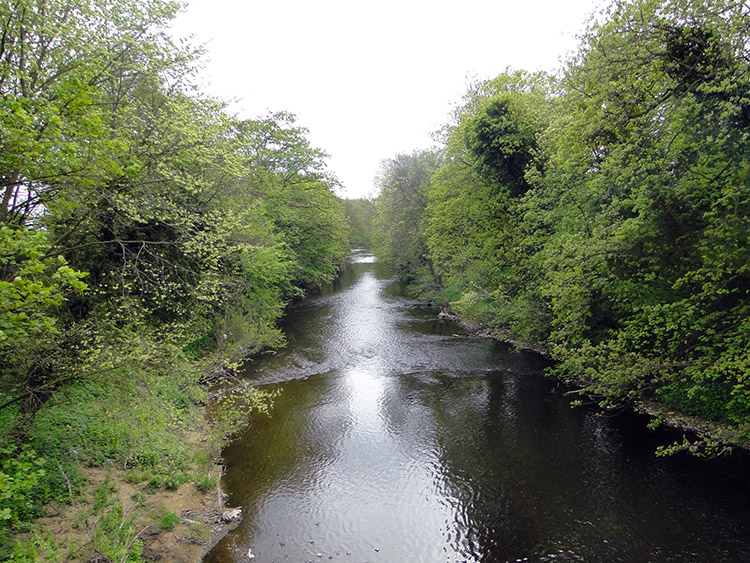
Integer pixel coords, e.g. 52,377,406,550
30,350,201,474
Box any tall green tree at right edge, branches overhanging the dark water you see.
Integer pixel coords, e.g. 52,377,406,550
539,0,750,430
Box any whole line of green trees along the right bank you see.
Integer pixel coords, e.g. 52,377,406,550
375,0,750,450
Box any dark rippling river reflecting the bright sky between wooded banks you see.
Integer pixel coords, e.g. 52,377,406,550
206,256,750,563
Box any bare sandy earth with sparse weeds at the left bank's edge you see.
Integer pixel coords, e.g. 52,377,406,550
13,427,241,563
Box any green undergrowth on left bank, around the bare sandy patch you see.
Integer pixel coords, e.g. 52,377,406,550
0,334,280,562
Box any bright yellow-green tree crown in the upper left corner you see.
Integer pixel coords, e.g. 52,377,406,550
0,0,183,227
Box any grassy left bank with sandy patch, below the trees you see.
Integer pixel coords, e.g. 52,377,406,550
0,332,271,561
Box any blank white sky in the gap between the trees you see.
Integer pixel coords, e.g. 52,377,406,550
174,0,601,197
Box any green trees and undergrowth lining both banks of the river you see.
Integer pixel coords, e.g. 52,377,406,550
0,0,750,561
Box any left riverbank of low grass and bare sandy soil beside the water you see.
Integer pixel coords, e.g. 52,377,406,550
0,356,269,562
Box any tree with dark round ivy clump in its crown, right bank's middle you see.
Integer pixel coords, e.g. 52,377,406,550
426,72,550,332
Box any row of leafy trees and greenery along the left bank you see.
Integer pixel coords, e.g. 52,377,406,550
0,0,349,560
